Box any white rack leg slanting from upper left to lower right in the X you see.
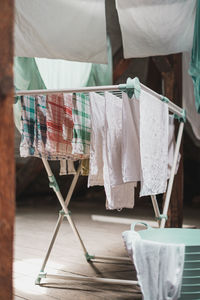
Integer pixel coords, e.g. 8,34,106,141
42,158,88,255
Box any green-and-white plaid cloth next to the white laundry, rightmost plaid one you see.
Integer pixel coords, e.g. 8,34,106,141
72,93,91,157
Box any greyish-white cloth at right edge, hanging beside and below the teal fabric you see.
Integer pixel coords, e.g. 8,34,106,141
182,53,200,140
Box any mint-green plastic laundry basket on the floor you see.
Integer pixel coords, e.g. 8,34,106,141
138,226,200,300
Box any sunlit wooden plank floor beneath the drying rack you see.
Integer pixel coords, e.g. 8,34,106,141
14,199,200,300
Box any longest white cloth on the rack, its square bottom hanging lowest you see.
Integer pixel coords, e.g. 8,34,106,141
103,92,136,209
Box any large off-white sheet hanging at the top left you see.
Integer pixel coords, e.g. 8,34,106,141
14,0,107,63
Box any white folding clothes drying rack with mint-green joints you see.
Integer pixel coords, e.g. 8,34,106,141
15,84,186,286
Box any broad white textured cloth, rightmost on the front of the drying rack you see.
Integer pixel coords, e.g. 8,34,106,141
139,89,169,196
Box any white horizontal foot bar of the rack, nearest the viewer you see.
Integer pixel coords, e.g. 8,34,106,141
45,274,138,285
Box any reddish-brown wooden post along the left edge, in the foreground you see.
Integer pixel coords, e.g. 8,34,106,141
0,0,15,300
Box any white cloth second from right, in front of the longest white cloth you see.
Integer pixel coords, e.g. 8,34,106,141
121,93,141,182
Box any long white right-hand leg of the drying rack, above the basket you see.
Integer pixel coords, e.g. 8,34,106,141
160,122,184,228
